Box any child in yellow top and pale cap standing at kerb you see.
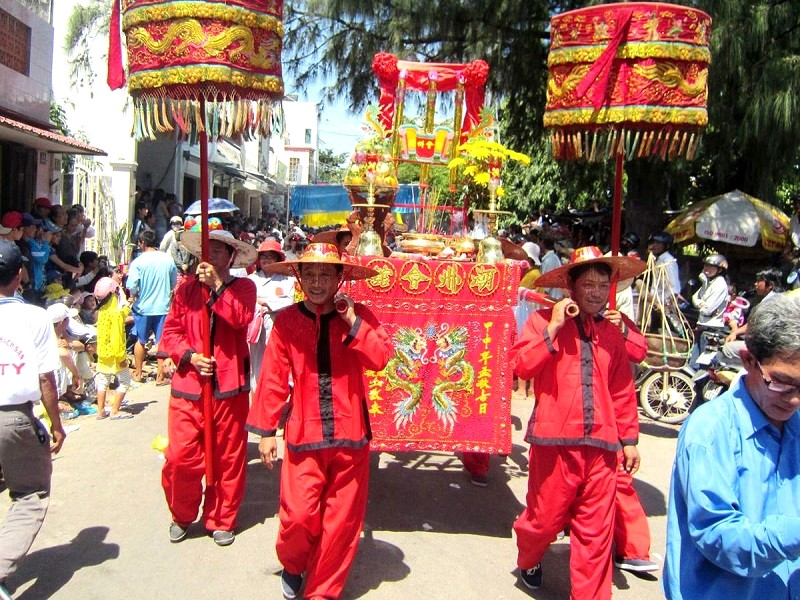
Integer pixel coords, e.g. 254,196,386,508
94,277,133,421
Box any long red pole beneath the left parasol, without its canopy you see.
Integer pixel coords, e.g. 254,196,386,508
197,96,214,482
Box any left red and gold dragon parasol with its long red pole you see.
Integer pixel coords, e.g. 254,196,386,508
108,0,283,485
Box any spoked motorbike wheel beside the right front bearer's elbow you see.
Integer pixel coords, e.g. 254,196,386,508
639,371,695,424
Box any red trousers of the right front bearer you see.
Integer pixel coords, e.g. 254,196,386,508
514,444,618,600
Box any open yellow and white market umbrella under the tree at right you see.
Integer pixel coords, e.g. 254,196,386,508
666,190,789,252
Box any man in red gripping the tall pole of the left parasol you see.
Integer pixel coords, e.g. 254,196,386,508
159,230,256,546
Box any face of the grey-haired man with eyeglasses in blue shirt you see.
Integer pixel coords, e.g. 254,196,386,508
742,350,800,428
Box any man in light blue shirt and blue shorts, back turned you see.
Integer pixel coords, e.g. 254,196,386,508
125,231,178,385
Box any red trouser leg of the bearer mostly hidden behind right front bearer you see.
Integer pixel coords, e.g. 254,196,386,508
614,451,650,560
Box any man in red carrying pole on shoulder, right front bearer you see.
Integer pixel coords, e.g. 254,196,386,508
510,246,645,600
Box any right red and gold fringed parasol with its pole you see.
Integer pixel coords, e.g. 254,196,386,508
544,2,711,306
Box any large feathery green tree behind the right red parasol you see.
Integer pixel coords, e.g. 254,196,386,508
285,0,800,220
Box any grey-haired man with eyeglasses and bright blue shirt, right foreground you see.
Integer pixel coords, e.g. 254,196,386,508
664,294,800,600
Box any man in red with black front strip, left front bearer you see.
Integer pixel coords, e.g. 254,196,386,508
247,243,394,599
